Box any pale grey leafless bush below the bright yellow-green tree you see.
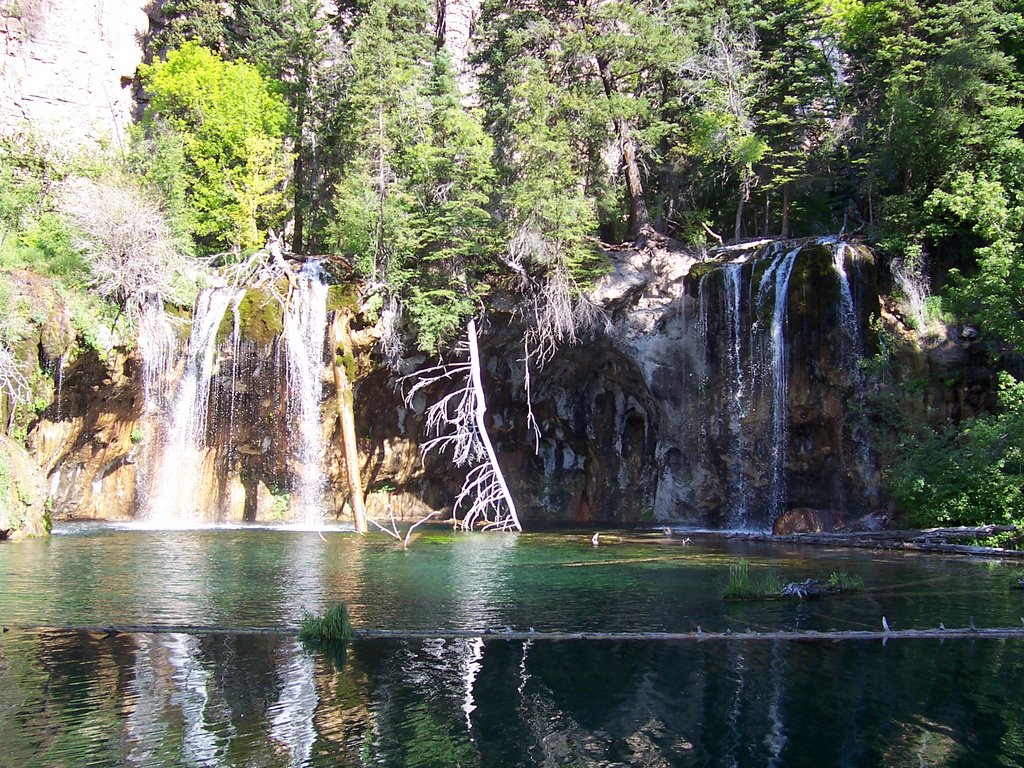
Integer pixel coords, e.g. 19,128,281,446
62,179,188,326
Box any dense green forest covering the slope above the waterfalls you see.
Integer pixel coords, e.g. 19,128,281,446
0,0,1024,536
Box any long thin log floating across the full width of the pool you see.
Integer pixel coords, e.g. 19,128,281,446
18,623,1024,642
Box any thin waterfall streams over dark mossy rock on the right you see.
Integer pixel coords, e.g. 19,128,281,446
691,239,872,529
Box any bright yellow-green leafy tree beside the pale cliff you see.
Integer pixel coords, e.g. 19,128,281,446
140,43,288,251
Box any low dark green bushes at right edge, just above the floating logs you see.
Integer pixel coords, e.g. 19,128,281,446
888,374,1024,526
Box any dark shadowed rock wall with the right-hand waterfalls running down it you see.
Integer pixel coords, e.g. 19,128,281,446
483,241,880,530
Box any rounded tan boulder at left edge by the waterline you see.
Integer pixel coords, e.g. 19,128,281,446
0,434,50,540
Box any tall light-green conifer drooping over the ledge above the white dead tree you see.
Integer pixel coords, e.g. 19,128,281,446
335,0,495,350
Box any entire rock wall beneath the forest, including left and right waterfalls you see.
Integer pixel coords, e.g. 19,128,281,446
30,241,881,530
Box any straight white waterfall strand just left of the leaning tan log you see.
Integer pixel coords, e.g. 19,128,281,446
285,261,328,525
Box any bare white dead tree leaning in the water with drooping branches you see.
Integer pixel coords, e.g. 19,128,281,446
402,319,522,530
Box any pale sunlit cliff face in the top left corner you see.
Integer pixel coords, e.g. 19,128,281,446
0,0,152,145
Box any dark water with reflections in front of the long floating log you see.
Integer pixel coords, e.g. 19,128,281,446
6,631,1024,768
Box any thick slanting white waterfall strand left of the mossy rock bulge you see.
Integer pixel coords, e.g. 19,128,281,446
144,288,241,523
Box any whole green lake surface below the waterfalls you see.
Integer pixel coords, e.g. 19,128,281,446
0,525,1024,768
